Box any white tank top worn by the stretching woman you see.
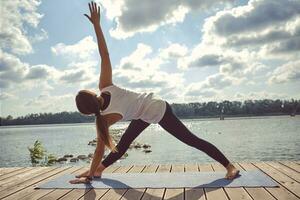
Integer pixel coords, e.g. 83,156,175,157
100,85,166,123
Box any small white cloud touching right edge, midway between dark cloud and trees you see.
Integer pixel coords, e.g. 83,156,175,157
268,60,300,84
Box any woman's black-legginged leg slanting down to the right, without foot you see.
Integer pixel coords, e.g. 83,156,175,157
159,102,230,168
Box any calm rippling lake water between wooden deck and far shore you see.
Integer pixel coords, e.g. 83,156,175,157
0,116,300,167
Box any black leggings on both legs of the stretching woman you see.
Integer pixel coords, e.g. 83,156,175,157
102,102,229,167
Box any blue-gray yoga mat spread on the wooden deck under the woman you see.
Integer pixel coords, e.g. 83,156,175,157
36,170,278,189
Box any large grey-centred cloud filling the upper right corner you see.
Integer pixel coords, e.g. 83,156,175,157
202,0,300,59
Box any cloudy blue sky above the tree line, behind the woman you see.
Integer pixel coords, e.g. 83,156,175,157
0,0,300,117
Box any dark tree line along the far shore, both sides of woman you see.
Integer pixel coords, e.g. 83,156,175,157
0,99,300,126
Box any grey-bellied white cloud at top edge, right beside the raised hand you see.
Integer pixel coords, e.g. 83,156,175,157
98,0,231,39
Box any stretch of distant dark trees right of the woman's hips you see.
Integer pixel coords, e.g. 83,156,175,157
172,99,300,118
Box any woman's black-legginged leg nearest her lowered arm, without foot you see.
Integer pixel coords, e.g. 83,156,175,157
102,119,150,168
